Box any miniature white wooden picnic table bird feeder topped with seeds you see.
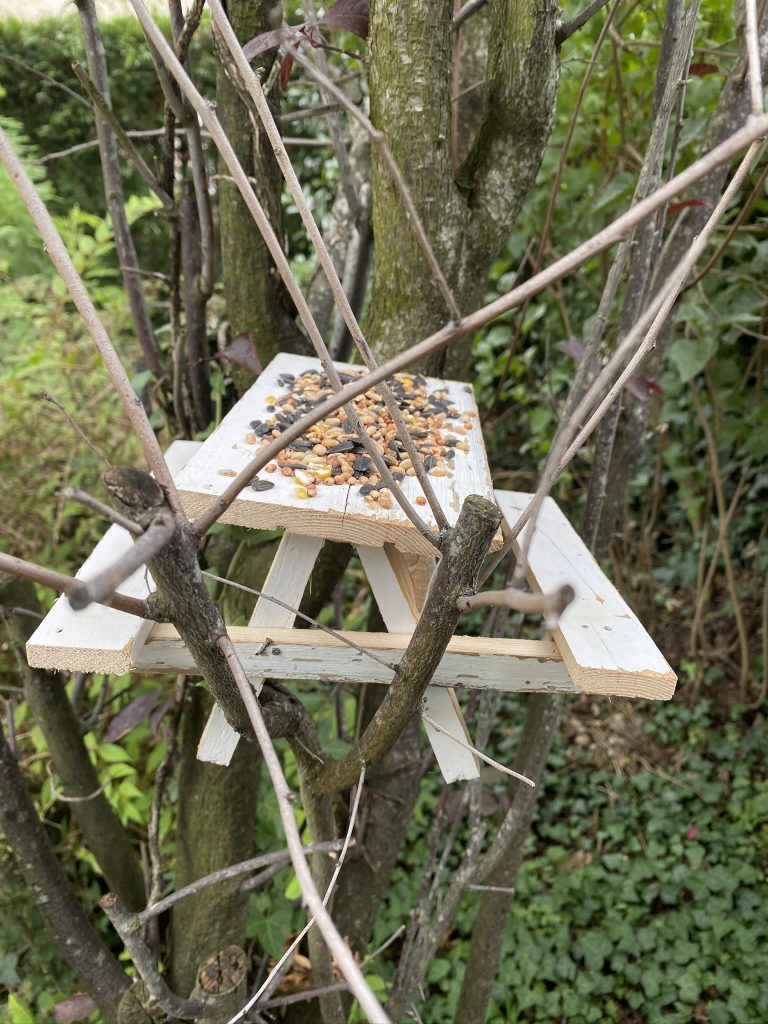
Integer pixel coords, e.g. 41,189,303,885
27,354,676,782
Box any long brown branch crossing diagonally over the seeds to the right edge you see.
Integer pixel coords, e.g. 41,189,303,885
195,115,768,551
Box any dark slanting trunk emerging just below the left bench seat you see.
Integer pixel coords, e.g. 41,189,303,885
0,580,146,910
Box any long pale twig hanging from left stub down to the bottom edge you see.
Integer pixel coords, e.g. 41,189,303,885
218,638,390,1024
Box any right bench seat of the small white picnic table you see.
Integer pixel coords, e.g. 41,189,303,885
496,490,677,700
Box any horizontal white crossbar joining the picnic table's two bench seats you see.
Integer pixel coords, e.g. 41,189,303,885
133,624,581,693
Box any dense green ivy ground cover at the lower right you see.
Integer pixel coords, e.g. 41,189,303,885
368,701,768,1024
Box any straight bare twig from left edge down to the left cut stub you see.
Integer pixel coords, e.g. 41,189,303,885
0,128,182,514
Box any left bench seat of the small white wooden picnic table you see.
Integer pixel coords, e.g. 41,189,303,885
27,441,202,675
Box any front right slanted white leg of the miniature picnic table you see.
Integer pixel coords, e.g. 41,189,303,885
357,544,479,782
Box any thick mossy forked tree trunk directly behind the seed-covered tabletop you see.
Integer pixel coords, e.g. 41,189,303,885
369,0,558,376
